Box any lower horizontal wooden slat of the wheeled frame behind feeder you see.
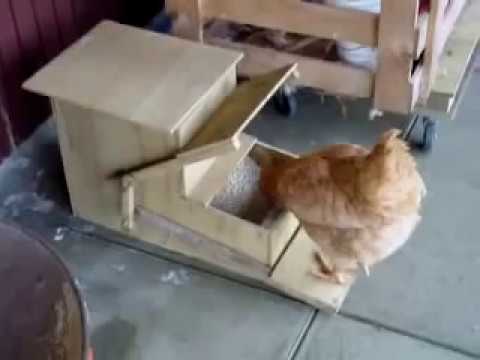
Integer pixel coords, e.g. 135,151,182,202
206,38,373,98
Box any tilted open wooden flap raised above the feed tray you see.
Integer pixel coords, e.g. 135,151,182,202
186,65,296,150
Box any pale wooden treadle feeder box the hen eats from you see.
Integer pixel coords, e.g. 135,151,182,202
25,22,350,310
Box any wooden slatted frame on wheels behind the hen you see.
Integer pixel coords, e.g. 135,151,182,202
167,0,469,114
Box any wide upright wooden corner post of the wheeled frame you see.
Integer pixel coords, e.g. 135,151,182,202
374,0,418,113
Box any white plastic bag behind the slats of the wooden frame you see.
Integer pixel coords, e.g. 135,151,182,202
325,0,380,71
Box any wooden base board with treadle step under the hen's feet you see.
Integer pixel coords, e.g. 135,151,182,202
128,210,352,312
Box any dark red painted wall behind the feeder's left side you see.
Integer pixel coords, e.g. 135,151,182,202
0,0,162,159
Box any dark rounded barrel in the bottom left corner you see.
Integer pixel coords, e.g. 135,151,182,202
0,224,87,360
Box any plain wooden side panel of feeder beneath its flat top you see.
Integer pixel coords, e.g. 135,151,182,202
53,100,174,229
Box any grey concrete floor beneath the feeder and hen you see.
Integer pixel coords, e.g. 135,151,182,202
0,54,480,360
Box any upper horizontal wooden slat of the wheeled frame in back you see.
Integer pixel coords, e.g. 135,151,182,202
201,0,378,47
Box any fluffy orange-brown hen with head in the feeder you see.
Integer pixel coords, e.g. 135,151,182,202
261,130,426,283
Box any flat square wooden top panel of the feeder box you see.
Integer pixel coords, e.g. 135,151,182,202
24,21,242,133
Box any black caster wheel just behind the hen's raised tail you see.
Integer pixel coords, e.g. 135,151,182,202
403,114,437,152
